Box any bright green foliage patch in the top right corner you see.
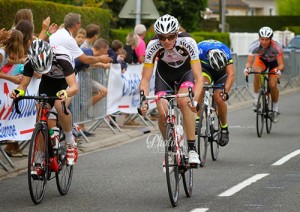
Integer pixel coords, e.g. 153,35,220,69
276,0,300,16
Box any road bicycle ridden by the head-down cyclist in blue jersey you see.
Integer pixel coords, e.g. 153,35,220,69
197,84,225,167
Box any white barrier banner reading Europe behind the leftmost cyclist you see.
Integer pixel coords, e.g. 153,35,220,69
0,78,40,141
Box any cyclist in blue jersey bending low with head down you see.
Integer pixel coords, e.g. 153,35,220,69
196,40,234,146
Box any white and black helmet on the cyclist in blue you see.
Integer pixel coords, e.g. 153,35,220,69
207,49,227,71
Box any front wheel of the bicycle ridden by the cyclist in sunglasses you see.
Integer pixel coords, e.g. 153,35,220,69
165,124,179,207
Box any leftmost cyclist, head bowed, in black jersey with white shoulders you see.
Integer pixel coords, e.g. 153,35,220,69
10,39,78,165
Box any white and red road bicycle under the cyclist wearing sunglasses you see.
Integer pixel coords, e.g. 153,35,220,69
140,87,195,207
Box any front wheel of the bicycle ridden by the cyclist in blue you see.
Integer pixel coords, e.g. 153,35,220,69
197,107,209,167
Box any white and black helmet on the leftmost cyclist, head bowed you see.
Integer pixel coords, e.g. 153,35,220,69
28,39,53,74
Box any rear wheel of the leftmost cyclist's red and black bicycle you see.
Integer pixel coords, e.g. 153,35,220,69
55,131,73,196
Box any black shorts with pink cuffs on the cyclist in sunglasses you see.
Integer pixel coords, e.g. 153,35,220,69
155,60,195,94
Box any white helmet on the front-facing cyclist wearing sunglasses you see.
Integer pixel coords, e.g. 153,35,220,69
154,14,179,35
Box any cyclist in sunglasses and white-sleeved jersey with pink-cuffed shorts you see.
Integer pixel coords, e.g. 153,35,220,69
140,14,203,167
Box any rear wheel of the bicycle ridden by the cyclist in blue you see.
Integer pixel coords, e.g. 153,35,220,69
210,111,221,161
